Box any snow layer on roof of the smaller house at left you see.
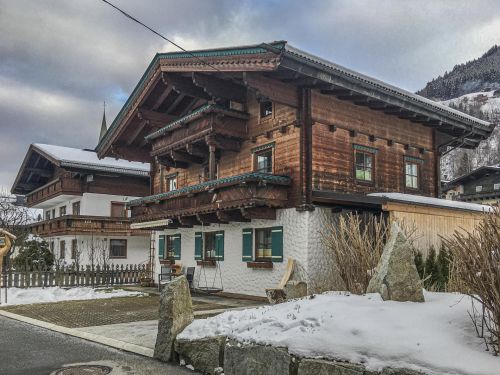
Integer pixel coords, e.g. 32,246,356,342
33,143,150,176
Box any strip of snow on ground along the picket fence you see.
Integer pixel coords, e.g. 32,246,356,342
0,287,144,306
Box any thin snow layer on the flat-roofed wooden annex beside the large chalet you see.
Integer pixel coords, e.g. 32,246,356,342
368,193,493,212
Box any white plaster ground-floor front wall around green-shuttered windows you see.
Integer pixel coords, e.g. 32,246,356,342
156,208,309,296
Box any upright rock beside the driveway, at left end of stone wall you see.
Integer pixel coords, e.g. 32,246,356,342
154,276,194,362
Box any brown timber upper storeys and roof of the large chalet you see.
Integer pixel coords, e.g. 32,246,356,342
97,42,491,226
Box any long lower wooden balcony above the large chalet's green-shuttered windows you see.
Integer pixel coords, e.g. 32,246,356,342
129,172,291,228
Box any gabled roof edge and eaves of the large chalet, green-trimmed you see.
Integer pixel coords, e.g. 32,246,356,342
96,41,494,156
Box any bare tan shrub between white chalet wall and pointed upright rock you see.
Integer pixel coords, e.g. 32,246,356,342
321,213,389,294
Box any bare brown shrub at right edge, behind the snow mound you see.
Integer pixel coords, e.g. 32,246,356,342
443,207,500,354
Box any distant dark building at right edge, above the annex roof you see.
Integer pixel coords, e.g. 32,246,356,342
443,165,500,204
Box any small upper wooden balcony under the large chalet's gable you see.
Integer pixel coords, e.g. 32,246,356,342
146,104,249,168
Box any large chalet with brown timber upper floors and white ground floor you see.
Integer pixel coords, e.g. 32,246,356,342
96,42,493,296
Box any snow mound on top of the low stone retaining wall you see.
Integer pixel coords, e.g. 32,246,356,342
179,292,500,375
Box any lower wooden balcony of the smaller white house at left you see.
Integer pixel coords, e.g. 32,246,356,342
29,215,148,237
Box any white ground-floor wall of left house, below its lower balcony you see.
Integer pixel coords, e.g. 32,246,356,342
45,235,150,266
